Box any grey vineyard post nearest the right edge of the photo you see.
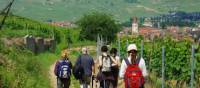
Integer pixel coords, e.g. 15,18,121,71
190,45,195,88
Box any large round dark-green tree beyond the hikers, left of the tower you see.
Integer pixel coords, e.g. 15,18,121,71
77,12,120,42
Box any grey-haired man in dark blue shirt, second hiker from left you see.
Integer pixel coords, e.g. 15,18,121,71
76,47,95,88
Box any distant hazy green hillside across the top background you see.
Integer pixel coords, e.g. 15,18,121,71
0,0,200,22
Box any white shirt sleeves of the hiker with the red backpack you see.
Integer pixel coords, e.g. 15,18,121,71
119,57,148,78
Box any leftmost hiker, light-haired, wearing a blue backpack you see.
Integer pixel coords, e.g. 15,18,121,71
54,49,72,88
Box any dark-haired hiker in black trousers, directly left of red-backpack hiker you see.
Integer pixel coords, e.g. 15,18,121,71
110,48,120,88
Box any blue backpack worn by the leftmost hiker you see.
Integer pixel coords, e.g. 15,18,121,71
57,60,71,79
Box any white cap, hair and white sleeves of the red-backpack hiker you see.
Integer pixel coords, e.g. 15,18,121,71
119,44,148,78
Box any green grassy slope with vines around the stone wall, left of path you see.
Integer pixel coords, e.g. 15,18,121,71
0,15,93,88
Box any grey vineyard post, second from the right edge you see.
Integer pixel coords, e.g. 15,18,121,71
162,46,165,88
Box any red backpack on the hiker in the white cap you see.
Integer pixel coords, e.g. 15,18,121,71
124,58,144,88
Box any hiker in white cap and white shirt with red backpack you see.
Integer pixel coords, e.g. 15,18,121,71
119,44,148,88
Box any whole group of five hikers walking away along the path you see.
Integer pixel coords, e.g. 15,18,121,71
54,44,148,88
